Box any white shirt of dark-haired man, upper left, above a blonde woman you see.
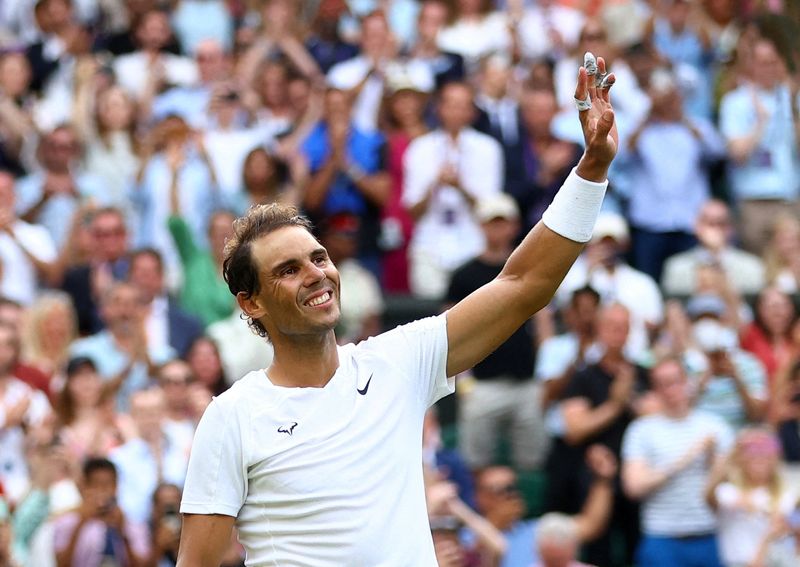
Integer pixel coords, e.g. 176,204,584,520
114,51,199,99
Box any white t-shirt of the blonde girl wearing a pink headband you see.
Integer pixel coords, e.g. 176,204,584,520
714,482,797,565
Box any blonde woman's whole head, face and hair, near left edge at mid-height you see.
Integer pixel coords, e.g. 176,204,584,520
22,291,78,378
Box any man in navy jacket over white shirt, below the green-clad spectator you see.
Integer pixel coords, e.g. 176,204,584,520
128,248,203,355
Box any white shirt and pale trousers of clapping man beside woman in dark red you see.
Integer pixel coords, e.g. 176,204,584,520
402,128,503,297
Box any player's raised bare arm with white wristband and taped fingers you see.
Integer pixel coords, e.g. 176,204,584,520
447,58,618,376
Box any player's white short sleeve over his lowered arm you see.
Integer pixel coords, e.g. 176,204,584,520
181,398,247,517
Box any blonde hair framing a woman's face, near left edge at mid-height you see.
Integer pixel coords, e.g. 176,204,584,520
22,291,78,369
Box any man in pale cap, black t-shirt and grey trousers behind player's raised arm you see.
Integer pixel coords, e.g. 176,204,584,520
446,193,548,470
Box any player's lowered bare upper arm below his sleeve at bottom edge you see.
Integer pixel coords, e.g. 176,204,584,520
177,514,236,567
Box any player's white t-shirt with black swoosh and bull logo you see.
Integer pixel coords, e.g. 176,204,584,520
181,315,455,567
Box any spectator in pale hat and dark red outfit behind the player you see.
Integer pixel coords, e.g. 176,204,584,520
381,74,428,293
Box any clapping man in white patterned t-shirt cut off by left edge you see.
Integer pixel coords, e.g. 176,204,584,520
0,324,50,505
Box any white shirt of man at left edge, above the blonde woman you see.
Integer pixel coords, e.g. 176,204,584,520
0,220,58,305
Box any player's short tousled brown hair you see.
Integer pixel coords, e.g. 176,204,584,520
222,203,311,337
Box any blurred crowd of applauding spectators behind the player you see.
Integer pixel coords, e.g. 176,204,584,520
0,0,800,567
